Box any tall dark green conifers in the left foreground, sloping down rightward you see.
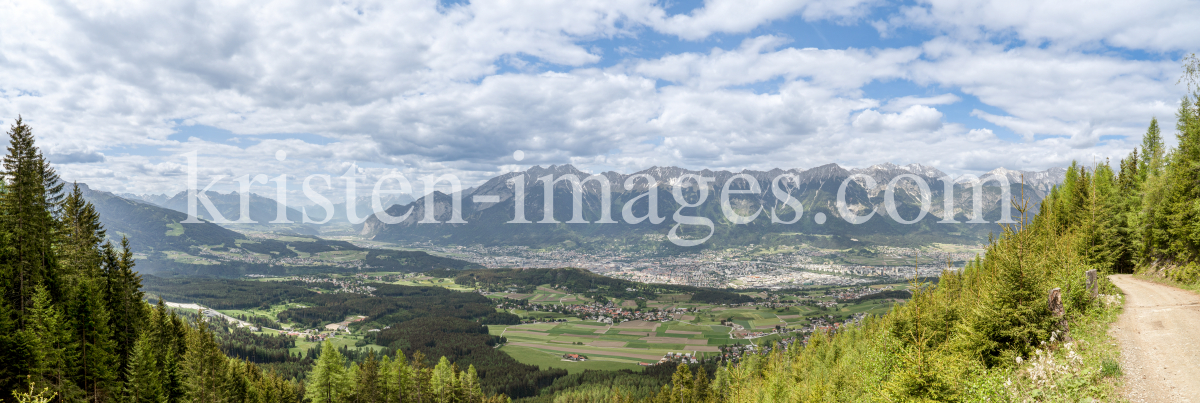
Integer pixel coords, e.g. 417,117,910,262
0,119,503,403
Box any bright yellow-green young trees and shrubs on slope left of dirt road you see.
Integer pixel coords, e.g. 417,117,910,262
638,140,1142,402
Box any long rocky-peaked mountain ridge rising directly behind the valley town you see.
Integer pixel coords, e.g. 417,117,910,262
360,163,1066,247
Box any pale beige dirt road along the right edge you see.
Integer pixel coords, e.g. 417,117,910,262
1109,275,1200,402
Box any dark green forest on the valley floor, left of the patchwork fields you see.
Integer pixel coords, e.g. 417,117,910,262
146,276,576,397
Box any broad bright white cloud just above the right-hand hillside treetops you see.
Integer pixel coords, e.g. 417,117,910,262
911,40,1182,140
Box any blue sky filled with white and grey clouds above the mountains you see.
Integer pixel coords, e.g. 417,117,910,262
0,0,1200,199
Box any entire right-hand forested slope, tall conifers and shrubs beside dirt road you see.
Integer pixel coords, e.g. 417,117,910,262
624,66,1200,402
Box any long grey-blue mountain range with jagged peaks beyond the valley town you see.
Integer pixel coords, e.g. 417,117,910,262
359,163,1066,249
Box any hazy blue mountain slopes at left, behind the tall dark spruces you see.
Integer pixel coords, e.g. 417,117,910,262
78,184,478,277
